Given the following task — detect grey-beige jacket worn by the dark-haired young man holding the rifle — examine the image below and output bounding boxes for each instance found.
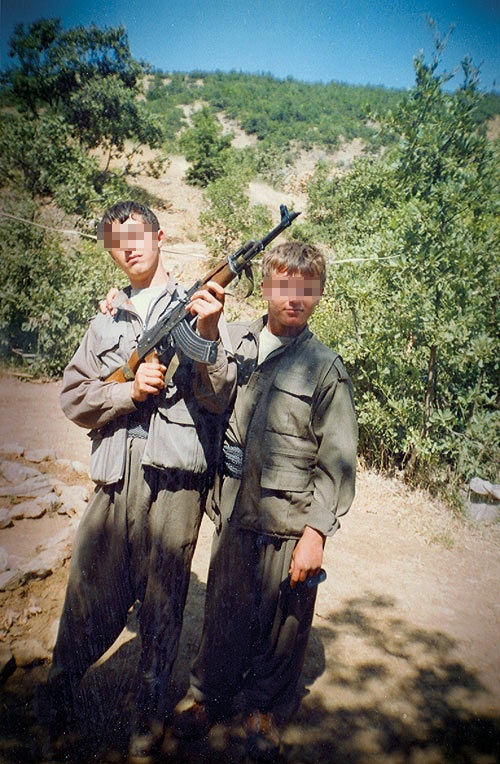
[61,280,236,484]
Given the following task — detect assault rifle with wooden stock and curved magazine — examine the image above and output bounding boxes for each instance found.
[106,204,300,382]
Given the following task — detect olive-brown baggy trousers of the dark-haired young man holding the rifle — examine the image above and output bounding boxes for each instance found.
[49,438,205,703]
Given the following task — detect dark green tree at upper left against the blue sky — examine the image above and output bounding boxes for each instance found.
[3,19,163,159]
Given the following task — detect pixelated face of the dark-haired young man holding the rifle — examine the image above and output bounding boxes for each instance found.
[101,218,164,289]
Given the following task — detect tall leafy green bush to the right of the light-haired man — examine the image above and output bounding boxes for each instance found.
[306,47,500,484]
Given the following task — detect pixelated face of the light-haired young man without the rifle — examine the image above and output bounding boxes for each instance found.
[262,271,323,337]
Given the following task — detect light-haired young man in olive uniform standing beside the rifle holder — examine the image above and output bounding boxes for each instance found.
[174,242,357,760]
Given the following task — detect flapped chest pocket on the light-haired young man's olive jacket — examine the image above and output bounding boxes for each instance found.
[268,370,315,438]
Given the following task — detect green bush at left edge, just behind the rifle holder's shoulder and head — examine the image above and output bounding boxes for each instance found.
[0,200,116,376]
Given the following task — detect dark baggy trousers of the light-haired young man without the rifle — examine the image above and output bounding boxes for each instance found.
[191,478,317,711]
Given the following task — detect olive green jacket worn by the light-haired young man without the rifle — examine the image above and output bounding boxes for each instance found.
[219,319,357,537]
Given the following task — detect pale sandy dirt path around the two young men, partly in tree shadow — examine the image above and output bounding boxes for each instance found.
[0,377,500,764]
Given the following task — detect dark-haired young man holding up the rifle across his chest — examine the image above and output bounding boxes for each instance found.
[40,202,236,757]
